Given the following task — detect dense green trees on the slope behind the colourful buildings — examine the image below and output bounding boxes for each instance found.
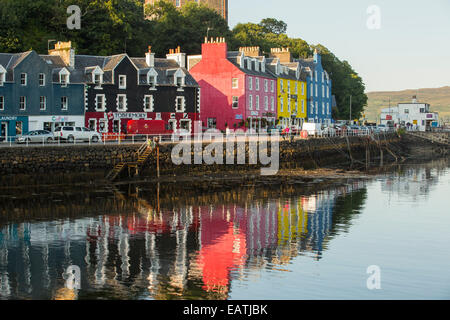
[0,0,367,119]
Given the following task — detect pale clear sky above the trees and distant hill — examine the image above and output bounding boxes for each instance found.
[229,0,450,92]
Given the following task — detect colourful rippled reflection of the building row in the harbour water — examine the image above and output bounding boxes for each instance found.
[0,179,363,299]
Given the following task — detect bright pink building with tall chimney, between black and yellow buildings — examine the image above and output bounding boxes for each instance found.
[188,38,277,130]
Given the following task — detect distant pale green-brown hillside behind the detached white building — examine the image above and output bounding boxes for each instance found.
[365,86,450,122]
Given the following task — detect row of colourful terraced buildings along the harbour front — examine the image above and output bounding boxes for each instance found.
[0,38,333,137]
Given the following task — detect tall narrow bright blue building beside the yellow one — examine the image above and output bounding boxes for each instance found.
[296,49,332,124]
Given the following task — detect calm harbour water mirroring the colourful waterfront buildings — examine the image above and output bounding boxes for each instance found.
[0,160,450,300]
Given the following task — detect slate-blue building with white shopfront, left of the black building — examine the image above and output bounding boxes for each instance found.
[0,42,85,140]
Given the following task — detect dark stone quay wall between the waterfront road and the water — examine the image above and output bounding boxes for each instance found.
[0,134,402,186]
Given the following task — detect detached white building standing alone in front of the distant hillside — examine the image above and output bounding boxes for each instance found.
[380,96,439,131]
